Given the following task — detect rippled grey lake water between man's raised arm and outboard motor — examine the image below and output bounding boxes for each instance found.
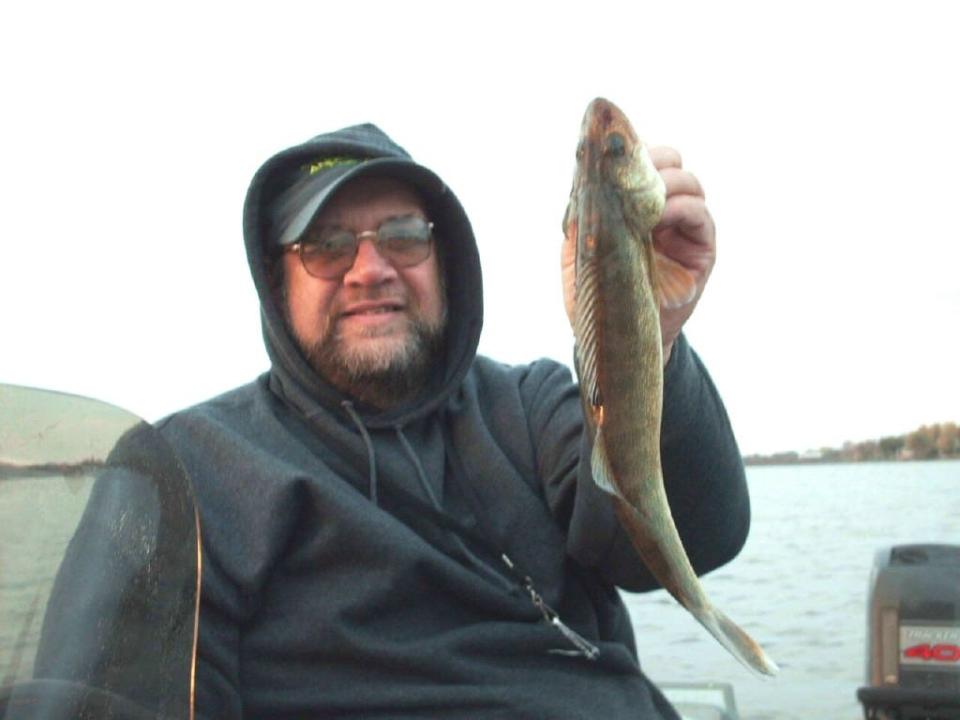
[625,461,960,720]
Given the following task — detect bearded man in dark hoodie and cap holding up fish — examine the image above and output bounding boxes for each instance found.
[160,125,749,720]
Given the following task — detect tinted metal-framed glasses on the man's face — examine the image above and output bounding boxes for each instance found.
[286,215,433,280]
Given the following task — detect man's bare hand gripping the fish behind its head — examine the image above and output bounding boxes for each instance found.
[560,147,717,364]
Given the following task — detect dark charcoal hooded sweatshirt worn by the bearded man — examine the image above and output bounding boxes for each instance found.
[160,125,749,720]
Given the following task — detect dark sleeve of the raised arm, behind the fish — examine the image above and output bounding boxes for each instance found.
[528,335,750,591]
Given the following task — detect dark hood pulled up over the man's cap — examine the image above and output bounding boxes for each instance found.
[237,124,483,428]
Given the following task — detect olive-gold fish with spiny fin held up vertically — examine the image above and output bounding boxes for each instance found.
[563,98,778,675]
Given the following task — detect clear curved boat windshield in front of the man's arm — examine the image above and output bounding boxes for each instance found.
[0,385,200,720]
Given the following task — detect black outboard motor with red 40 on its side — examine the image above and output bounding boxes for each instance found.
[857,545,960,720]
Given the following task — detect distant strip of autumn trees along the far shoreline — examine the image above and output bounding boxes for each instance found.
[743,422,960,465]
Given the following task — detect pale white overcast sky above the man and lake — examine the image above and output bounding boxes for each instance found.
[0,0,960,454]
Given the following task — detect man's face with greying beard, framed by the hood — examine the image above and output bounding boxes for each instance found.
[283,178,446,408]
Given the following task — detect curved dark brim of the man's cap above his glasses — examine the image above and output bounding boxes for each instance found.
[275,157,446,247]
